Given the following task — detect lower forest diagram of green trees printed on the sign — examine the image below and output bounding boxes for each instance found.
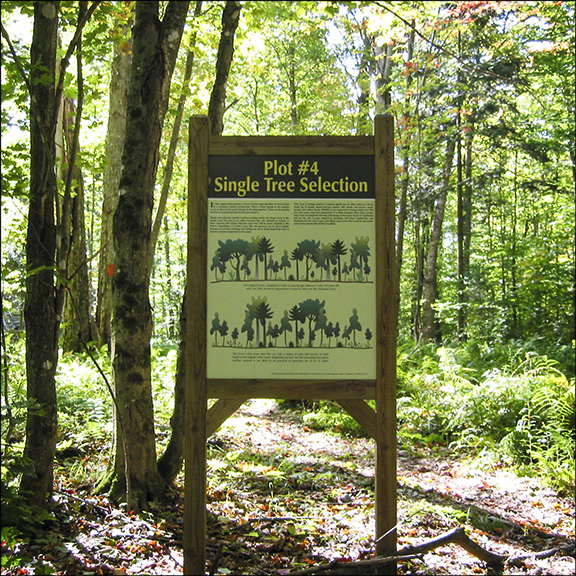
[210,296,373,349]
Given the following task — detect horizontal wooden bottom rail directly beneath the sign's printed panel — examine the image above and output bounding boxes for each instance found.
[208,378,376,400]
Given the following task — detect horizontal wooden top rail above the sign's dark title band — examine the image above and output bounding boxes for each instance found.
[210,136,374,156]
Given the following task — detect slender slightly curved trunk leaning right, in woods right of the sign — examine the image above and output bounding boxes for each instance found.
[422,134,456,341]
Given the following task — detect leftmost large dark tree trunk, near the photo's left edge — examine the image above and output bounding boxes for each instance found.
[20,1,59,506]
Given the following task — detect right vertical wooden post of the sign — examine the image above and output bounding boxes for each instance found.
[374,115,398,574]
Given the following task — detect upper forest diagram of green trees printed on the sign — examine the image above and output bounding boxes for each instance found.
[210,236,372,282]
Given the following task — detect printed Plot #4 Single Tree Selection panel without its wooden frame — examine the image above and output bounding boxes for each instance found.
[207,155,376,379]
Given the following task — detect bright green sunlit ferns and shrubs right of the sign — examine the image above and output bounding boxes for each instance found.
[398,347,575,492]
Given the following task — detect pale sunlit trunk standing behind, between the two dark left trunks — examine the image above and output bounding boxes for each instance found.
[96,19,132,346]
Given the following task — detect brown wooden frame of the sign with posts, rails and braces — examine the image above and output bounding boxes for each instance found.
[183,115,397,574]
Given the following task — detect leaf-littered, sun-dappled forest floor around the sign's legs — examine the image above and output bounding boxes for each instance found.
[2,401,575,575]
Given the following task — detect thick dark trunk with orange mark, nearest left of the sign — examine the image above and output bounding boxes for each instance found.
[105,0,189,510]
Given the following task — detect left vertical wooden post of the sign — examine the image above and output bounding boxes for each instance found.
[183,116,209,575]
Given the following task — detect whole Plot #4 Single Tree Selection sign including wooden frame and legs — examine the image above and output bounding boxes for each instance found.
[183,116,397,574]
